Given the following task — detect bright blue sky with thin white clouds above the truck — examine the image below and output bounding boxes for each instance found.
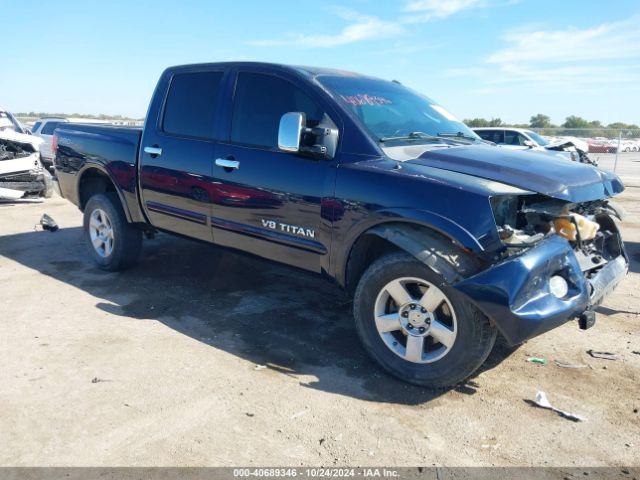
[0,0,640,124]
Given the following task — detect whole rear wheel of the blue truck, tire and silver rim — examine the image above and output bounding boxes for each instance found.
[84,193,142,271]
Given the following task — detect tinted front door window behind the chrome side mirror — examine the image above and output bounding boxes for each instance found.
[231,73,324,148]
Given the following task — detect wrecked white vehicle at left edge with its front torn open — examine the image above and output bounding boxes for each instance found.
[0,128,53,200]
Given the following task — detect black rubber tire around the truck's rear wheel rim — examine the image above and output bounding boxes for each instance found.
[83,192,142,272]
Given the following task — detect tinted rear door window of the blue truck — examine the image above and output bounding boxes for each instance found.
[162,72,222,139]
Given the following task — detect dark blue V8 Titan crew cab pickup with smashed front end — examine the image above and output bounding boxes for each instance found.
[54,63,628,387]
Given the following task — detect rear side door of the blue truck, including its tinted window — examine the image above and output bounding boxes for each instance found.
[139,69,224,241]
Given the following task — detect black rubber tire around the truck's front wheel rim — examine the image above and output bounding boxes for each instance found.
[353,252,497,388]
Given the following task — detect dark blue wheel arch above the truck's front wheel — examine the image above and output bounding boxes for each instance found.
[342,220,483,292]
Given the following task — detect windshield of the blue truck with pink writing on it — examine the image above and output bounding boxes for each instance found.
[318,75,479,141]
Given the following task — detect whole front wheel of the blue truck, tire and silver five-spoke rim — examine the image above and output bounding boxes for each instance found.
[354,253,497,388]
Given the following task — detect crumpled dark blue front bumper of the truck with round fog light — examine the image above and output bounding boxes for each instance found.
[454,235,628,345]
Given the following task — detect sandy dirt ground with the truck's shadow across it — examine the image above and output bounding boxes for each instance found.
[0,156,640,466]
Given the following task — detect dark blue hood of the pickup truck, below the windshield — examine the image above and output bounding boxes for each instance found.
[385,145,624,203]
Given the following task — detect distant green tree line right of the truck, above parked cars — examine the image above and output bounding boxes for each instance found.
[463,113,640,137]
